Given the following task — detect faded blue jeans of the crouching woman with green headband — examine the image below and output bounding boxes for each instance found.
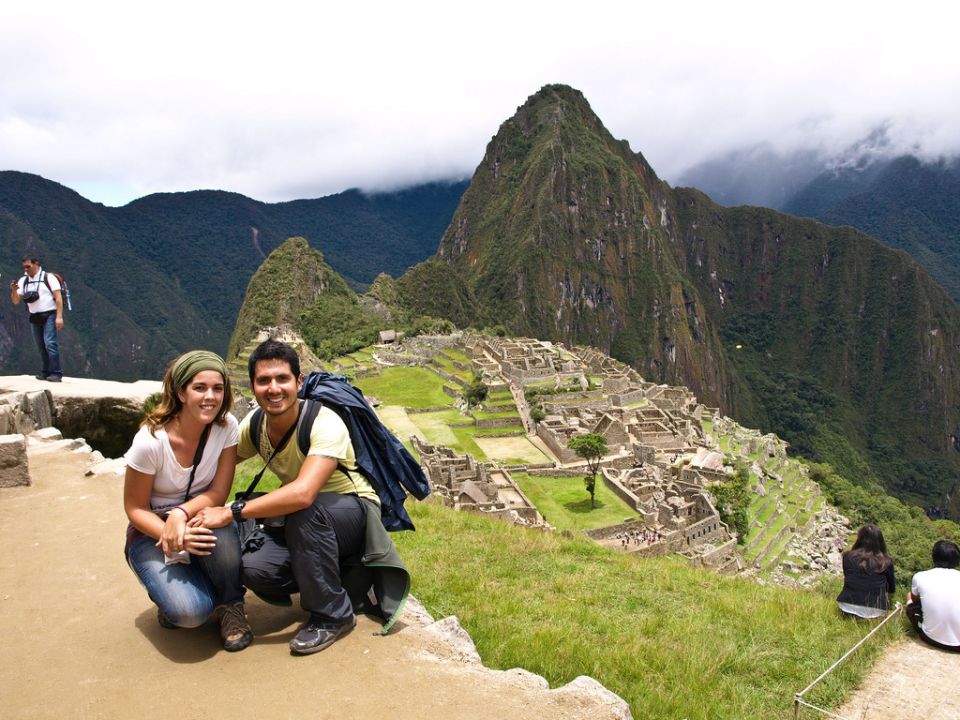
[127,523,243,627]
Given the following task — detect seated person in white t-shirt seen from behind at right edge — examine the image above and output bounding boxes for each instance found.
[906,540,960,652]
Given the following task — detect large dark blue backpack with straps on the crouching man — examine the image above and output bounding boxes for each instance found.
[250,372,430,532]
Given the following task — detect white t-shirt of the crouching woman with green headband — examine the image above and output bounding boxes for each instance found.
[124,413,240,512]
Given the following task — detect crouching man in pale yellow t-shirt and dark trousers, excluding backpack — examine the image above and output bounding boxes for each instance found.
[196,340,410,655]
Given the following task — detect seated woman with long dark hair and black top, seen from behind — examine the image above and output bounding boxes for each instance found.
[837,525,894,618]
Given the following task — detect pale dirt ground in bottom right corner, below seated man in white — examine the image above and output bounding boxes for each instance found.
[832,638,960,720]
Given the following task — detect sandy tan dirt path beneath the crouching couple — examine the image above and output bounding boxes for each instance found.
[0,451,623,720]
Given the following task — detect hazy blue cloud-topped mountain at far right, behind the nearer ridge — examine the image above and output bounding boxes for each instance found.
[784,156,960,301]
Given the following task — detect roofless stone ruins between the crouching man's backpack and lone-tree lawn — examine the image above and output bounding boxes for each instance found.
[411,436,546,527]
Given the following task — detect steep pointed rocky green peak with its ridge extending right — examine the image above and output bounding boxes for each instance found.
[397,85,960,506]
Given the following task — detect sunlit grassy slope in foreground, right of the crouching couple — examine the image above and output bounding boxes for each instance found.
[394,502,902,720]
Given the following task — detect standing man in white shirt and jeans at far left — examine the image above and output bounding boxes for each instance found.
[10,255,63,382]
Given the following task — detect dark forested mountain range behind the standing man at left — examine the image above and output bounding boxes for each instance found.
[0,172,466,380]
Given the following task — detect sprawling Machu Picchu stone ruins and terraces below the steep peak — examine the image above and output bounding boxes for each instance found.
[237,328,849,584]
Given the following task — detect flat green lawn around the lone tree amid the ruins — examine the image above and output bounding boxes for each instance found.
[513,473,637,531]
